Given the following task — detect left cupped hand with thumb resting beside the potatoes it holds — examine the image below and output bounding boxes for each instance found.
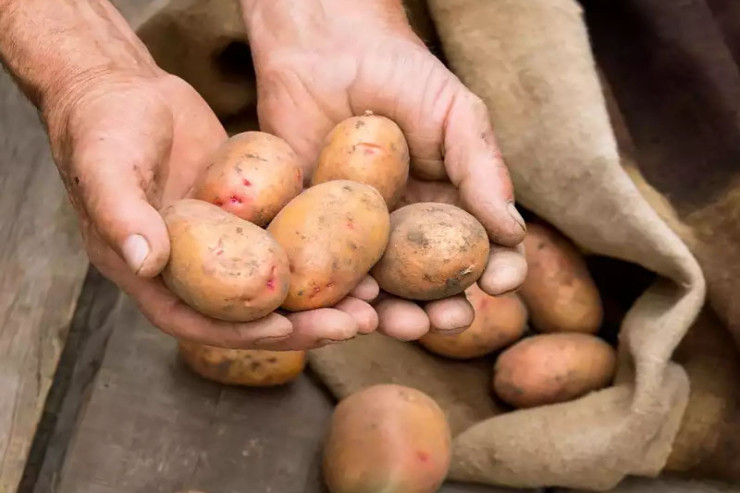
[46,74,378,350]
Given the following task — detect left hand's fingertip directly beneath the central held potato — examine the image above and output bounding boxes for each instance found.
[281,308,359,349]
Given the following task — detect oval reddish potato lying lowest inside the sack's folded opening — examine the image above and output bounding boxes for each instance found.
[493,332,616,408]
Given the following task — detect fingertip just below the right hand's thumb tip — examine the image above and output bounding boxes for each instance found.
[478,243,527,296]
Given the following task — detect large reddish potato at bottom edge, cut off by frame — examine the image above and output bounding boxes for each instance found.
[323,384,451,493]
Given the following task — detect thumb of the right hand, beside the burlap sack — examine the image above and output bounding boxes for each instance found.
[444,88,526,247]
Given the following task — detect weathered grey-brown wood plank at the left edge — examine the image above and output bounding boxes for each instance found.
[0,68,88,493]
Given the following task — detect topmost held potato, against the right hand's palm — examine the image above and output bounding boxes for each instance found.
[311,111,409,208]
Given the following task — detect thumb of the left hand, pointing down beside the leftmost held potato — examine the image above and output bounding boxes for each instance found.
[74,145,170,277]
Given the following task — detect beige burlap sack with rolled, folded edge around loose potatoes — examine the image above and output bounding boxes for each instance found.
[132,0,740,490]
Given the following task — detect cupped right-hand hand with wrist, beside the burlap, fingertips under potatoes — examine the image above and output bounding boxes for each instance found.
[242,0,526,340]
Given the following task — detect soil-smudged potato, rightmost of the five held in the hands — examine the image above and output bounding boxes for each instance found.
[372,202,490,300]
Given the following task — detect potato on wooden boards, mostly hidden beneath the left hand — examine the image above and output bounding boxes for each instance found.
[178,341,306,387]
